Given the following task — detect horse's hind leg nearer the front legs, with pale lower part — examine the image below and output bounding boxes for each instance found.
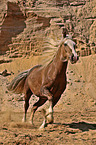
[29,98,47,124]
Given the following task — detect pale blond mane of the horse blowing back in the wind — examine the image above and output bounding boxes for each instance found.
[40,35,72,66]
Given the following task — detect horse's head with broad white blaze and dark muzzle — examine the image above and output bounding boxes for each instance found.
[63,35,79,63]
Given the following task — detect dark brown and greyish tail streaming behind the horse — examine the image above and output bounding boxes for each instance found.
[7,69,31,94]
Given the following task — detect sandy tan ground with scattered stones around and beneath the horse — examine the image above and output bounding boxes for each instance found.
[0,55,96,145]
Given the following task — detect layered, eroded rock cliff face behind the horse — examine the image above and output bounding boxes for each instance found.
[0,0,96,56]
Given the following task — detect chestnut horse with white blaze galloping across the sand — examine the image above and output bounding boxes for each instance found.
[8,32,79,128]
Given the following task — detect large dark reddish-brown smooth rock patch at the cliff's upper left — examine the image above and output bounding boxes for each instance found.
[0,2,26,54]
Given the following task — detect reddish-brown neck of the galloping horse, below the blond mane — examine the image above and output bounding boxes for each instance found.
[53,46,68,72]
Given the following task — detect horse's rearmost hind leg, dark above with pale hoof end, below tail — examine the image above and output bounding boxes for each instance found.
[22,90,32,122]
